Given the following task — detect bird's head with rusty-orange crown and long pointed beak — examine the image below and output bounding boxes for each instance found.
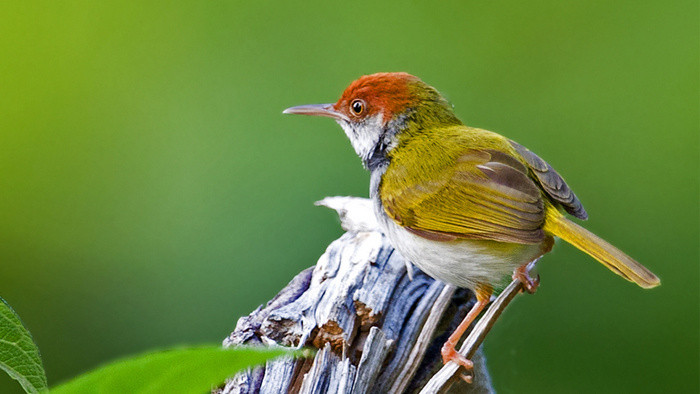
[284,73,461,169]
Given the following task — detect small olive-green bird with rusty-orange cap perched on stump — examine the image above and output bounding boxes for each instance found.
[283,72,660,380]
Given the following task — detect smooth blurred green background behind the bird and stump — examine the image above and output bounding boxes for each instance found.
[0,0,700,393]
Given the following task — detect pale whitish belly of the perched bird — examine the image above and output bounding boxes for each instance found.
[378,215,542,289]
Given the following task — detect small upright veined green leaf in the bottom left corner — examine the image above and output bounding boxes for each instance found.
[0,297,48,393]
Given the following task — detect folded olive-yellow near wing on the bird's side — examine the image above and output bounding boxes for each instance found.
[379,149,545,244]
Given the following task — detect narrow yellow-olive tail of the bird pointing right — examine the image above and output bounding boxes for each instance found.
[544,207,661,289]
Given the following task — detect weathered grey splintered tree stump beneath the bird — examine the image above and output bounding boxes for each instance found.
[215,197,500,394]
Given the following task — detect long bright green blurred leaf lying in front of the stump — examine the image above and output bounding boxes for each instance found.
[51,345,303,394]
